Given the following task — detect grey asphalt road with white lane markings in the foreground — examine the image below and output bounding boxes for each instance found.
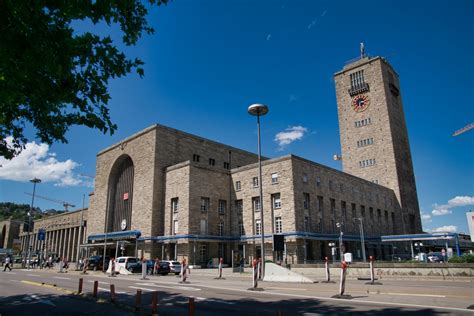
[0,269,474,316]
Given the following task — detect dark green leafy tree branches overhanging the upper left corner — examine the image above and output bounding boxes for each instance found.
[0,0,168,159]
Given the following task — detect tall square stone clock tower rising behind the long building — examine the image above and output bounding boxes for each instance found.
[334,46,422,234]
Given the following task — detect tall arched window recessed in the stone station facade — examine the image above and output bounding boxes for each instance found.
[106,155,134,232]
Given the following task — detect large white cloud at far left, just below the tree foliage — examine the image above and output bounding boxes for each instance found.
[0,137,91,186]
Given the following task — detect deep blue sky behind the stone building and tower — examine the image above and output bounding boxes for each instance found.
[0,0,474,232]
